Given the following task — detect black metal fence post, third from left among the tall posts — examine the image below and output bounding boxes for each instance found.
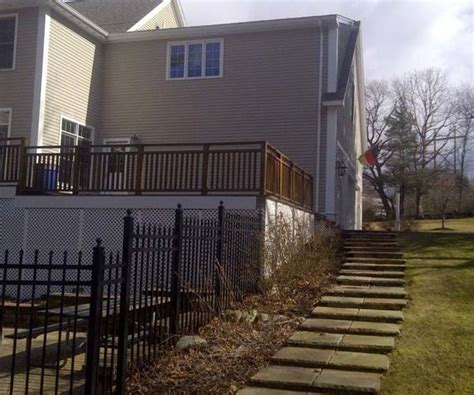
[170,204,183,335]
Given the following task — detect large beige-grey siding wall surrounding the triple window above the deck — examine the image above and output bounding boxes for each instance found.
[100,28,320,174]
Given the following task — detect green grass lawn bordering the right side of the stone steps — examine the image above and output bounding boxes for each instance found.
[382,234,474,394]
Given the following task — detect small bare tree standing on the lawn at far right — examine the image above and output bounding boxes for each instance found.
[428,170,457,229]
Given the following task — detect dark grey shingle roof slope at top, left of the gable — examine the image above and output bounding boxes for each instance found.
[64,0,163,33]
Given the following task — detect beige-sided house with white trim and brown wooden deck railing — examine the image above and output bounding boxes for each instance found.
[0,0,367,232]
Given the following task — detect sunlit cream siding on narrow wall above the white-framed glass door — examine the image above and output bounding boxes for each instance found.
[43,14,103,145]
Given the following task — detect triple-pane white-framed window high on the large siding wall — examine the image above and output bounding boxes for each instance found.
[167,39,224,80]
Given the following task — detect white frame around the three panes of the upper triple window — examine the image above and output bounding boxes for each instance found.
[166,38,224,81]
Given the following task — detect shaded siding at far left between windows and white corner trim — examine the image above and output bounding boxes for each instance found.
[0,8,38,139]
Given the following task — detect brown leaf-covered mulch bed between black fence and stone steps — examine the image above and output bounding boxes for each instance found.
[127,273,334,394]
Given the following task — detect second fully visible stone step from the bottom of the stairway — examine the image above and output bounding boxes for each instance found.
[271,347,389,373]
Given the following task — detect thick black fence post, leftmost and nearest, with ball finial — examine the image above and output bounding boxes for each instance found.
[85,239,105,395]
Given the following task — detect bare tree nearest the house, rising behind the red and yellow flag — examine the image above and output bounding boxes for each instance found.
[364,80,394,217]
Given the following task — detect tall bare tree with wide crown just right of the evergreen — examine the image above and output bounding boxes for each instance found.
[393,69,454,215]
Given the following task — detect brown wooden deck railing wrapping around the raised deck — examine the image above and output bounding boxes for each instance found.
[0,142,313,208]
